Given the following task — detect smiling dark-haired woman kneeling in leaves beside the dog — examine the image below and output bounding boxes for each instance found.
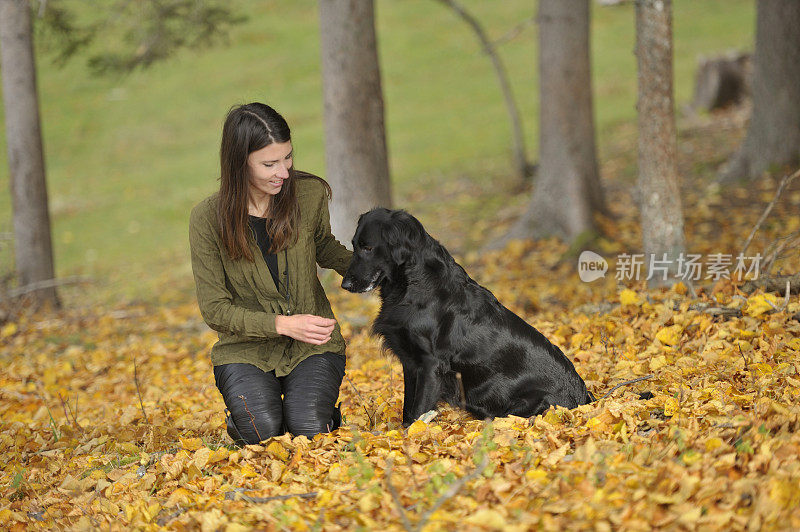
[189,103,352,444]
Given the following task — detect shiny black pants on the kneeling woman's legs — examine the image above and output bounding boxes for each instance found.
[214,352,345,444]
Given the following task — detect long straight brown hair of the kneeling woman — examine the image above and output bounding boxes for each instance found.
[217,103,331,262]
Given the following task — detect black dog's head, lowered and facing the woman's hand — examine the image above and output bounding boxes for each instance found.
[342,208,425,292]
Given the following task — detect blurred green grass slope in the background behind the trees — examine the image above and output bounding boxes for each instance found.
[0,0,755,306]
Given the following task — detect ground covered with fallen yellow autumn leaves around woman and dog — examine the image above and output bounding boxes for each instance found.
[0,110,800,530]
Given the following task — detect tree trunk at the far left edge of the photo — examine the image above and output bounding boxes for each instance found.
[0,0,58,306]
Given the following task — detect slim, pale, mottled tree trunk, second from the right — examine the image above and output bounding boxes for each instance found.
[636,0,685,287]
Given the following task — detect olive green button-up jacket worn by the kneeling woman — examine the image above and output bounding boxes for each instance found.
[189,176,352,377]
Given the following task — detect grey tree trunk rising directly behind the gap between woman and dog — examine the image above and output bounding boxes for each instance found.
[319,0,391,246]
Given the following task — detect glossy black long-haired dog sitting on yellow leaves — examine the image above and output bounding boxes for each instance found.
[342,208,594,426]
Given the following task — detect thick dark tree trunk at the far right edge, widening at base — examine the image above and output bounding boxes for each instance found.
[721,0,800,182]
